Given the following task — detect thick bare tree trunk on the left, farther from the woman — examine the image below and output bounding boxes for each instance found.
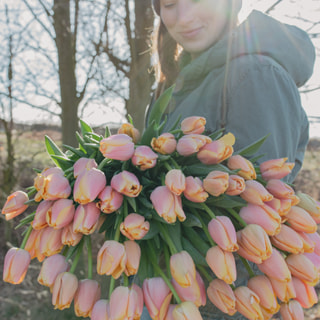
[53,0,79,146]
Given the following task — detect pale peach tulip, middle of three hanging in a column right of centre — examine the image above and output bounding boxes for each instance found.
[206,246,237,284]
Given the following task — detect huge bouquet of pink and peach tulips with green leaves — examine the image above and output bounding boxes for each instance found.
[2,88,320,320]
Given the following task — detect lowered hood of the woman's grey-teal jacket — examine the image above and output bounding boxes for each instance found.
[181,11,315,87]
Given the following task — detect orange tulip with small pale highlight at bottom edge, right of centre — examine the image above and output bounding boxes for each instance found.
[234,286,264,320]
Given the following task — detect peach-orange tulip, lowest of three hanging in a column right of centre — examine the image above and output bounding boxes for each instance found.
[207,279,237,316]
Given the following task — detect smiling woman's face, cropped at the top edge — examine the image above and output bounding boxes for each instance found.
[160,0,231,57]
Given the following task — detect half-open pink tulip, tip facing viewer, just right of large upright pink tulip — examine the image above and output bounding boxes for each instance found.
[111,170,142,198]
